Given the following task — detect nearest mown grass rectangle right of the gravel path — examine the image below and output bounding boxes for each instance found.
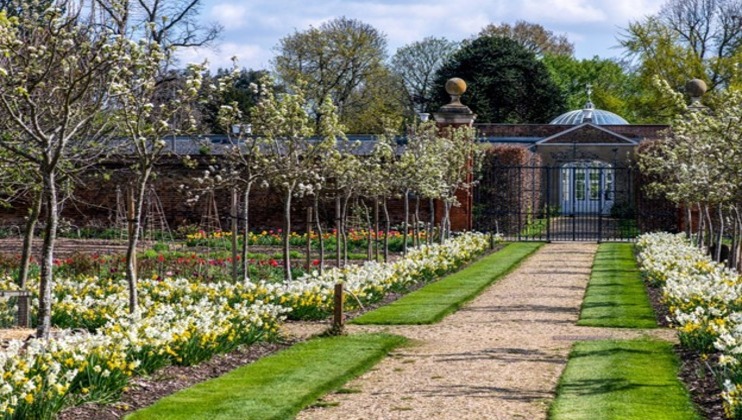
[549,340,701,420]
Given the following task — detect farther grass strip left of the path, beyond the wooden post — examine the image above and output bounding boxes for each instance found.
[352,242,543,325]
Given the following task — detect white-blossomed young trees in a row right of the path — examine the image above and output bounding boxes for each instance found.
[639,80,742,266]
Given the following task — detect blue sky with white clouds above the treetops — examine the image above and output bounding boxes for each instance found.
[180,0,665,70]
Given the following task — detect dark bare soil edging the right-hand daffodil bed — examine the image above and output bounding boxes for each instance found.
[647,280,726,420]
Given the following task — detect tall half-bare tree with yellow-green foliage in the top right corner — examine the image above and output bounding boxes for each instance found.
[620,0,742,122]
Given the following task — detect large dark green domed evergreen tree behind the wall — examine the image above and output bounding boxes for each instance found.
[434,36,565,123]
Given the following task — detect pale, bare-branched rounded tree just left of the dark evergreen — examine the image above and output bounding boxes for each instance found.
[391,36,458,113]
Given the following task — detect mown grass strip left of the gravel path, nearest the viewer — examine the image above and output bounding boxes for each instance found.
[127,334,406,420]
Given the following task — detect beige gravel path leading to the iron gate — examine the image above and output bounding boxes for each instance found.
[297,243,674,420]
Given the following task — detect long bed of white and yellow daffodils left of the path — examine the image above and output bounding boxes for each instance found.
[0,233,500,419]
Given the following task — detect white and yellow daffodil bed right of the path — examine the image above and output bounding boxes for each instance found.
[637,233,742,418]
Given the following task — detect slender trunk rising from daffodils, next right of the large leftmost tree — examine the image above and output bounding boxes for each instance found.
[126,170,150,313]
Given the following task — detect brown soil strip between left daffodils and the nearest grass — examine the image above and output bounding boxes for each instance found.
[56,342,293,420]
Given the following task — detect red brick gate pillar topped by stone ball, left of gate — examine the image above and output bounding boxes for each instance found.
[433,77,477,231]
